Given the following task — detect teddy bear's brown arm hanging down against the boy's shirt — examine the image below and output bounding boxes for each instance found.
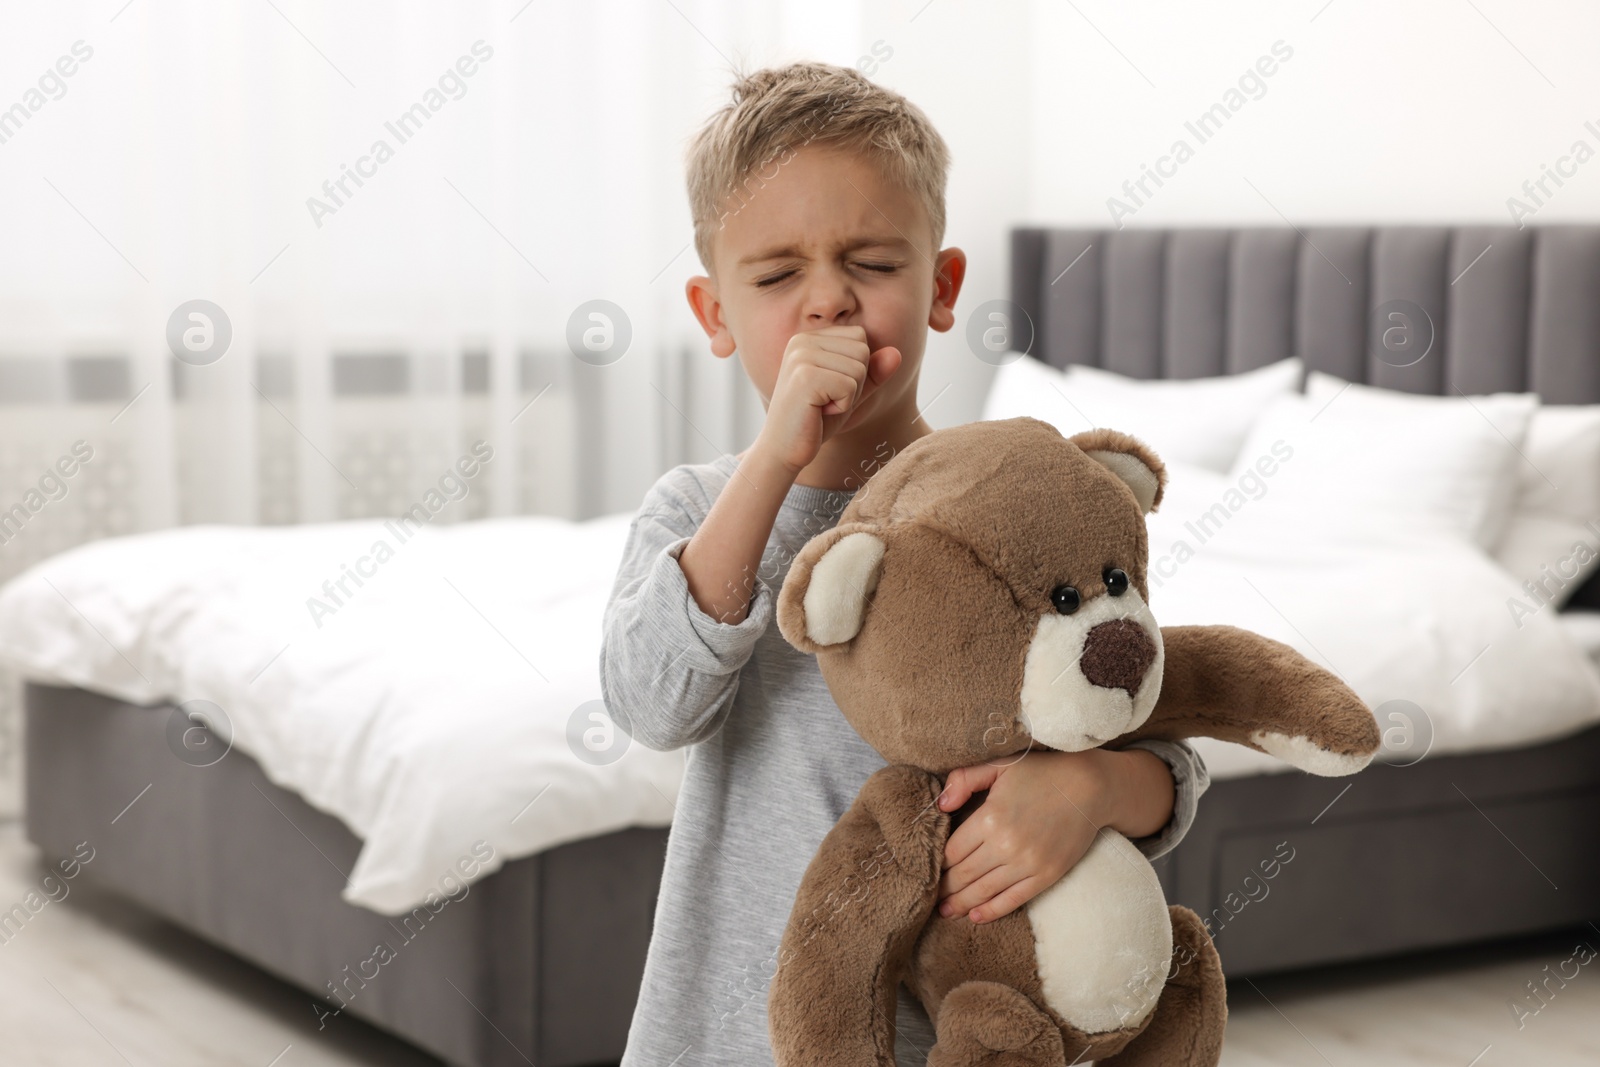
[766,766,949,1067]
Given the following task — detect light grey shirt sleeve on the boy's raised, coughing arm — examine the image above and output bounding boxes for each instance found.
[600,472,773,750]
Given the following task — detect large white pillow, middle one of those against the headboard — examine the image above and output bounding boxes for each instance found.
[1235,371,1538,553]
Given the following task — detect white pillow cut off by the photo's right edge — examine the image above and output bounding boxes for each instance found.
[1494,405,1600,606]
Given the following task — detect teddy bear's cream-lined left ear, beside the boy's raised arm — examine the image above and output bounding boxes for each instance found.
[778,523,885,653]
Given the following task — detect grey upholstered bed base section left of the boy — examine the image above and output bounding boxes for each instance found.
[24,683,667,1067]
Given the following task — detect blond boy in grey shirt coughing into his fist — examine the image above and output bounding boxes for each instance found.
[600,64,1206,1067]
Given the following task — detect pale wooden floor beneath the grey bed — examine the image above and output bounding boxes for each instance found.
[0,821,1600,1067]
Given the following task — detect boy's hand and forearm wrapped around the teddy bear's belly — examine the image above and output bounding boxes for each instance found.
[939,749,1176,923]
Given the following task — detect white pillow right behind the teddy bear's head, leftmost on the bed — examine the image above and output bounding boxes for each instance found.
[982,357,1302,474]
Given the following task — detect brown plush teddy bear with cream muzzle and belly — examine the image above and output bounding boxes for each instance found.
[768,418,1379,1067]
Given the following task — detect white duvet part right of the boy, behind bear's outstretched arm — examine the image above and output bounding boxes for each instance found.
[1149,466,1600,777]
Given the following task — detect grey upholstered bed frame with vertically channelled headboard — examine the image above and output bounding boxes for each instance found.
[26,220,1600,1067]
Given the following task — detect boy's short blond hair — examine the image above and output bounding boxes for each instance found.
[688,62,950,270]
